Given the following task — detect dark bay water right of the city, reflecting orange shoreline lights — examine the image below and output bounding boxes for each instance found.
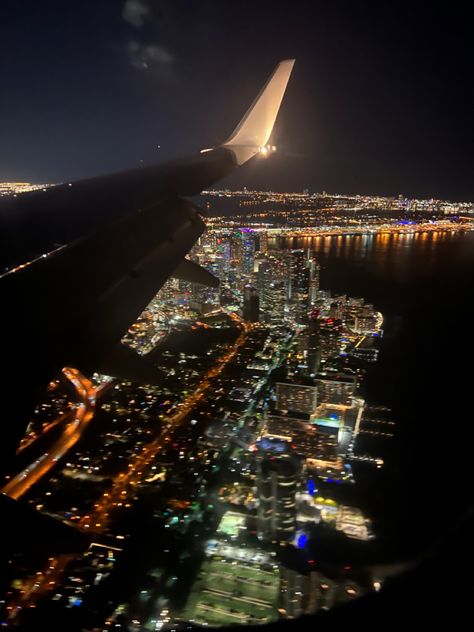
[271,232,474,548]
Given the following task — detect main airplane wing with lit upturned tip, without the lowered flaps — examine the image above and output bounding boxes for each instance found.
[0,60,294,273]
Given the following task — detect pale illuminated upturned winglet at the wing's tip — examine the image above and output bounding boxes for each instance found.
[222,59,295,165]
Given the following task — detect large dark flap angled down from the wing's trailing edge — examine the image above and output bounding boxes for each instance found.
[2,198,205,375]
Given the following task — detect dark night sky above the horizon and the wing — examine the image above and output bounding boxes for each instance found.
[0,0,474,200]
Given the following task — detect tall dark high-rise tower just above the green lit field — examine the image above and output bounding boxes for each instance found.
[257,454,299,541]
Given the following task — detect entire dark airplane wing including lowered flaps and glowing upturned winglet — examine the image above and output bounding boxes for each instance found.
[0,60,294,467]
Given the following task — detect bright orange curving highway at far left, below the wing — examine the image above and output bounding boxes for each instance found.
[1,368,98,500]
